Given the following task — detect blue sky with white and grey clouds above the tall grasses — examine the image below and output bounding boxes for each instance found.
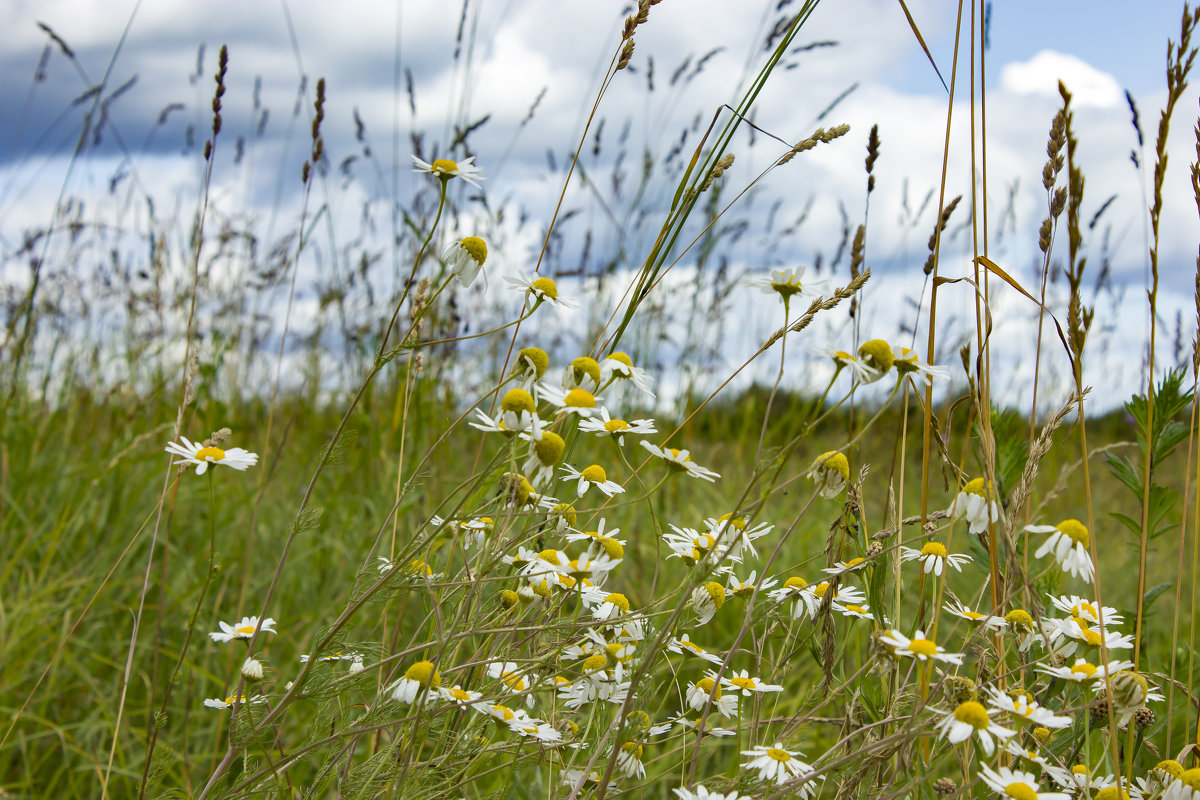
[0,0,1200,410]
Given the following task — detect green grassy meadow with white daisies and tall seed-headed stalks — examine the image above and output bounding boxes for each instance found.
[0,0,1200,800]
